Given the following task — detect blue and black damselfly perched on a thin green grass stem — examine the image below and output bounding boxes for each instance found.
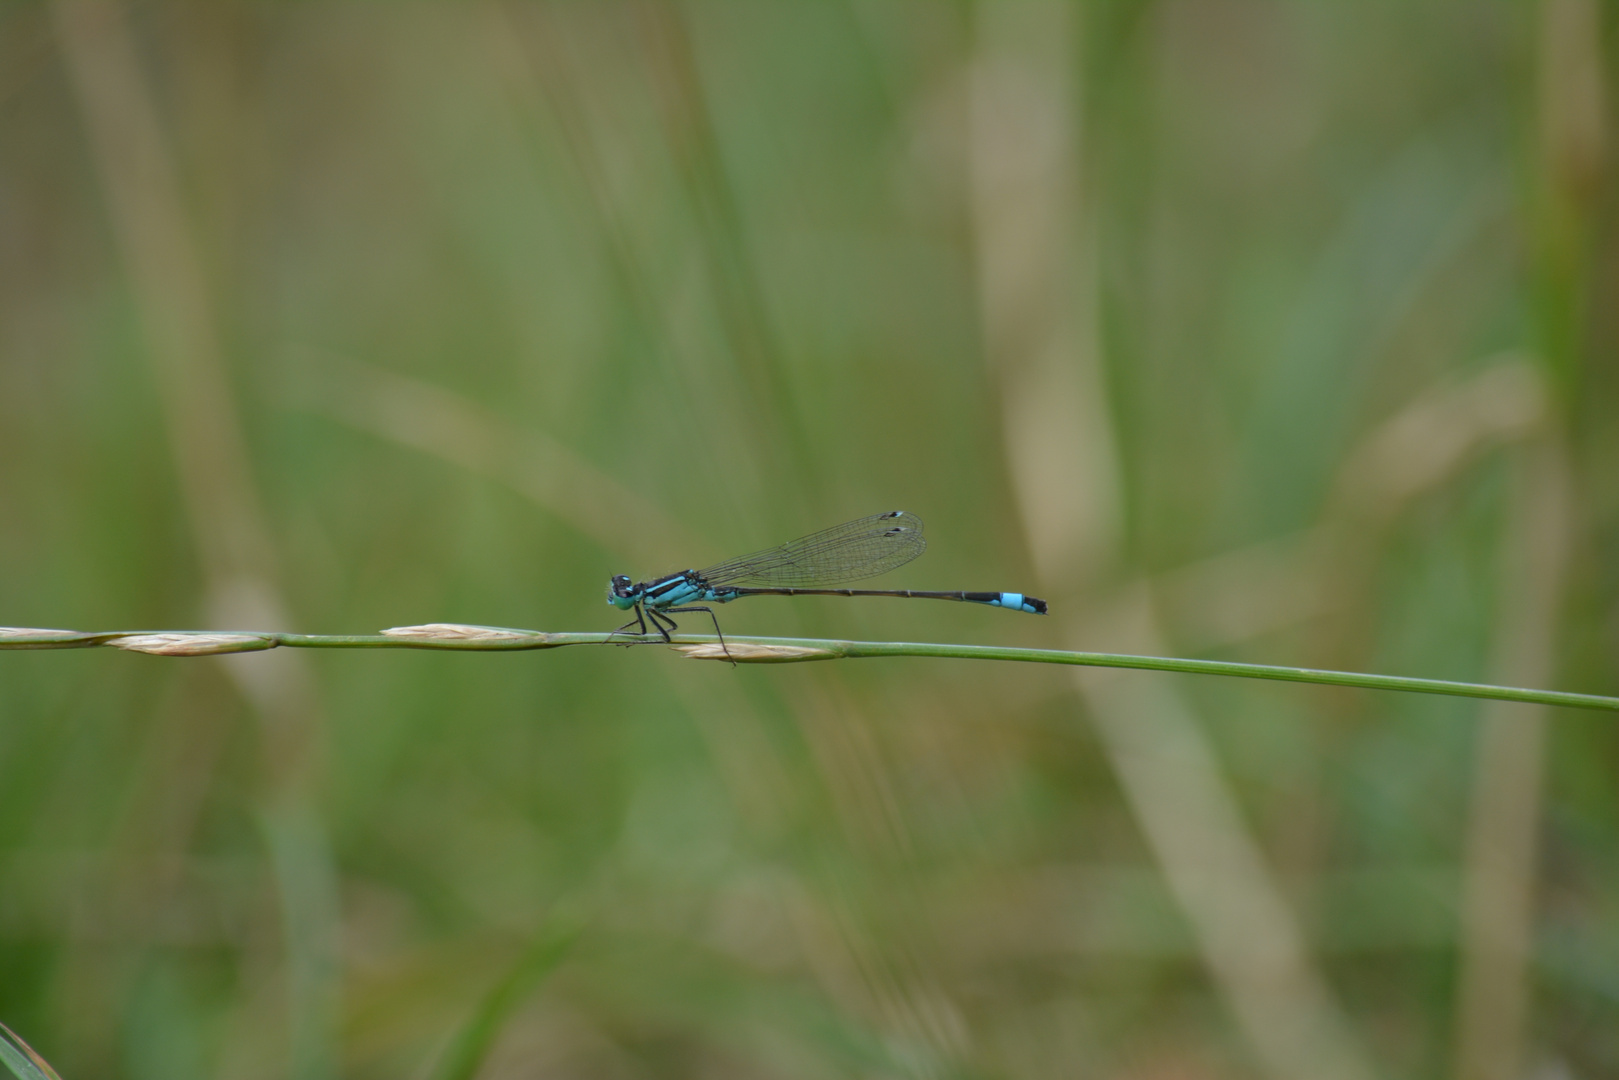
[607,510,1046,656]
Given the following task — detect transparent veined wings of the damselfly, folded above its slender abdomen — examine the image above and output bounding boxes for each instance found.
[698,510,928,588]
